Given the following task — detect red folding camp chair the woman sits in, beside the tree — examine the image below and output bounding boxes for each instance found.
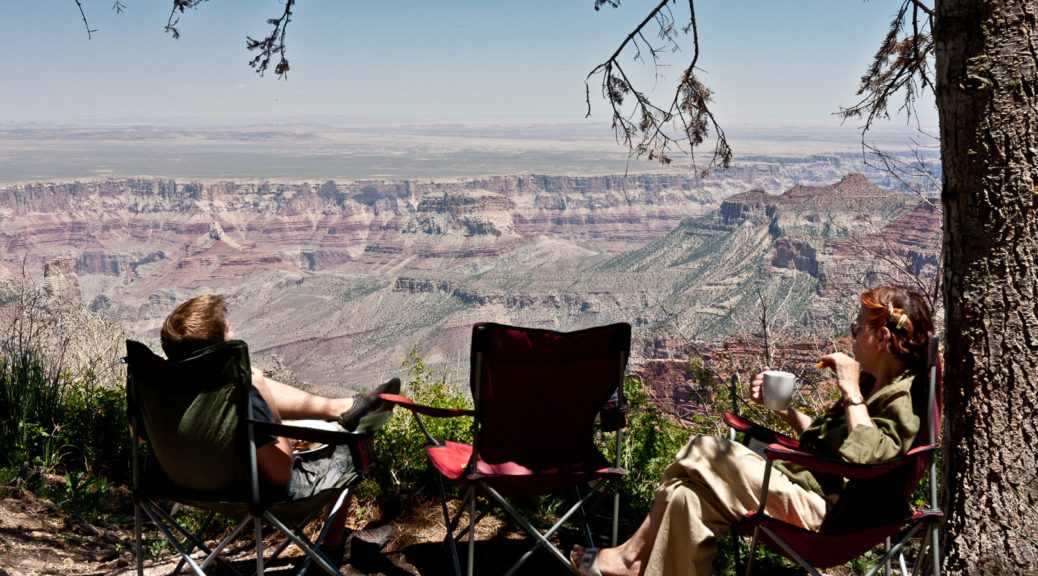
[725,336,944,576]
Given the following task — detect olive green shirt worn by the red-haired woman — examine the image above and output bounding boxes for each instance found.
[774,371,921,499]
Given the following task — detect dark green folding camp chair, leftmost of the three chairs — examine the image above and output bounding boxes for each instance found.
[125,340,377,576]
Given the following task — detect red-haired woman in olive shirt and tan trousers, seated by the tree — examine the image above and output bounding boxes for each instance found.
[571,284,933,576]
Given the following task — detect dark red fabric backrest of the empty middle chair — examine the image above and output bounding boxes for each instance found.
[470,324,631,471]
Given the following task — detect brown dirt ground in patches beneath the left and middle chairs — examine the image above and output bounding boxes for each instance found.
[0,481,571,576]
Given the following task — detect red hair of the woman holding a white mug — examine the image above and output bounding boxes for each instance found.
[862,284,933,368]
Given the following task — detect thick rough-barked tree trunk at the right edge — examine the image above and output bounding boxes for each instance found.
[933,0,1038,576]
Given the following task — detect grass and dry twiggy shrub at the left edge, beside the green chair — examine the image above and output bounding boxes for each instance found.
[0,275,129,482]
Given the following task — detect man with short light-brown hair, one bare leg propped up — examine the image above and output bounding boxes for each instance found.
[161,294,400,561]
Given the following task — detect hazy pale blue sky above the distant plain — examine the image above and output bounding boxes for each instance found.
[0,0,935,126]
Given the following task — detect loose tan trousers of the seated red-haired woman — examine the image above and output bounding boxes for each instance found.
[645,436,828,576]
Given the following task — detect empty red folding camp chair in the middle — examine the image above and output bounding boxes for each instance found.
[382,324,631,575]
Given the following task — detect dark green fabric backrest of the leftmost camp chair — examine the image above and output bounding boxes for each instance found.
[126,340,252,499]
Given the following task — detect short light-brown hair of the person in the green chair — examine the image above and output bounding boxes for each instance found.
[161,294,227,360]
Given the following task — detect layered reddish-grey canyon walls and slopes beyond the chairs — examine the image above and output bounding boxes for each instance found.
[0,161,940,392]
